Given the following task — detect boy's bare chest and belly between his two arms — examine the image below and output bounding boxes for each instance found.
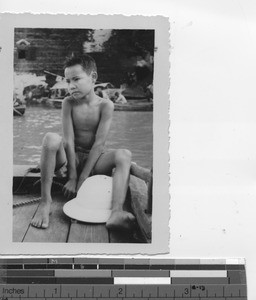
[69,97,107,150]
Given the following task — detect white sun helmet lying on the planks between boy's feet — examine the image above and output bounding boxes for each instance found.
[63,175,112,223]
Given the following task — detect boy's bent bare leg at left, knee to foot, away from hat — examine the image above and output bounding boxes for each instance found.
[31,133,66,228]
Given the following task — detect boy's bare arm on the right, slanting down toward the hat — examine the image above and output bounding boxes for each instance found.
[77,100,114,191]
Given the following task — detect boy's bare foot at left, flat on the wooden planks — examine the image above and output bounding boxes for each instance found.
[31,201,51,229]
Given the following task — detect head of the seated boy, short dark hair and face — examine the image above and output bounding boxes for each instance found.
[64,55,98,99]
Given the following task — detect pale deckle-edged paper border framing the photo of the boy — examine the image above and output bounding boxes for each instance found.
[0,14,170,255]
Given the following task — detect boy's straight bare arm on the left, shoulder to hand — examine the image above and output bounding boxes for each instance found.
[62,98,77,198]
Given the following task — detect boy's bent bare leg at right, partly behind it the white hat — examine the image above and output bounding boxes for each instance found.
[94,149,135,229]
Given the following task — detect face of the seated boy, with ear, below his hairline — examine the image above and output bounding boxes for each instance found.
[65,65,97,99]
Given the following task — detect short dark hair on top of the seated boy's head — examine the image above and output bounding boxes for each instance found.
[64,54,97,74]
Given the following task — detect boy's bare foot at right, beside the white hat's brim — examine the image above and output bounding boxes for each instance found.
[106,210,135,230]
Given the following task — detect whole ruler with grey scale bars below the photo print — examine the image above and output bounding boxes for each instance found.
[0,257,247,300]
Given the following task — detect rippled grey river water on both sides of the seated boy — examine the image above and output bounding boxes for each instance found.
[13,106,153,168]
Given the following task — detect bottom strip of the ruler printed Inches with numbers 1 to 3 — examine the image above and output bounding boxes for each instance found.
[0,284,246,300]
